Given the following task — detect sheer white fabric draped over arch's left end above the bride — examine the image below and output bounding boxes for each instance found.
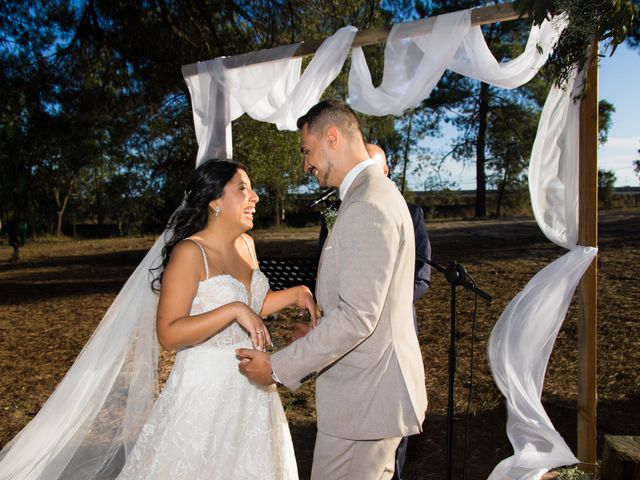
[185,26,357,165]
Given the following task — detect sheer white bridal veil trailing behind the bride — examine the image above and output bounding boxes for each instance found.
[0,237,164,480]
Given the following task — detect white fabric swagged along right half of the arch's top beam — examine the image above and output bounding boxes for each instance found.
[349,10,565,115]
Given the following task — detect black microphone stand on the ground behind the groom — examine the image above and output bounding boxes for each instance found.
[417,256,493,480]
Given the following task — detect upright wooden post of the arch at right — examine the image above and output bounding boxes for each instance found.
[577,41,598,467]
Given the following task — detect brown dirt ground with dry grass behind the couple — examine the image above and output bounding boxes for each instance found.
[0,211,640,480]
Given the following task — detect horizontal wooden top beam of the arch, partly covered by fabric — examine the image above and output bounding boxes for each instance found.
[182,3,520,77]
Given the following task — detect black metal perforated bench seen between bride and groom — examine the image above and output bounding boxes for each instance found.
[260,258,318,292]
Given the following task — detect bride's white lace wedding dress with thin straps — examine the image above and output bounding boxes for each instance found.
[118,237,298,480]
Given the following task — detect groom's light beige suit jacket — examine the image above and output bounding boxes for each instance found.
[271,166,427,440]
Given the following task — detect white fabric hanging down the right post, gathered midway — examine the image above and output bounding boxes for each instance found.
[488,66,597,480]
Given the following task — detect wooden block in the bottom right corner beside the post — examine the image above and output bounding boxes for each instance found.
[600,435,640,480]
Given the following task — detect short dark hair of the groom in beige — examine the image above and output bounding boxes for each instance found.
[297,100,363,139]
